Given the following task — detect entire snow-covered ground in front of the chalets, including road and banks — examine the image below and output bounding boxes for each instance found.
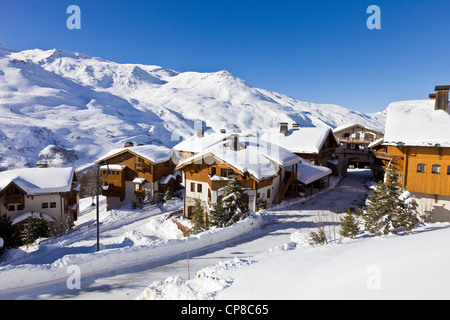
[0,170,450,300]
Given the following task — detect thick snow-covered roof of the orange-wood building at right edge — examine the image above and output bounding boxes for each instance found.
[384,100,450,148]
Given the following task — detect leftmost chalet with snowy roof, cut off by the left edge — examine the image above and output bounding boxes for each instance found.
[0,168,80,226]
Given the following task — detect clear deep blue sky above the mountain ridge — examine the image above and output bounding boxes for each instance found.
[0,0,450,113]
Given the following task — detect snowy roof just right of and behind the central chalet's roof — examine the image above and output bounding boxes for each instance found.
[261,127,337,153]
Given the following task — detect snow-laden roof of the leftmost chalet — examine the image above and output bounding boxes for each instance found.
[0,168,75,196]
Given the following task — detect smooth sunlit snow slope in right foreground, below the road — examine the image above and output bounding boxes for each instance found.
[137,223,450,300]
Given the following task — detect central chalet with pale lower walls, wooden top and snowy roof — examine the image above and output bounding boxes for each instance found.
[176,134,301,218]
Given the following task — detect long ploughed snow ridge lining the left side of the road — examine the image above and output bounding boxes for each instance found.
[0,210,264,289]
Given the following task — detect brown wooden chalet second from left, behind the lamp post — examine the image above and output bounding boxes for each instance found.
[96,144,180,210]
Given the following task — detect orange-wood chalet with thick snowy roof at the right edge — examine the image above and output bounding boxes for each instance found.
[371,86,450,222]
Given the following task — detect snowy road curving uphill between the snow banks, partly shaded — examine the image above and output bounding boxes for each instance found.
[1,170,370,300]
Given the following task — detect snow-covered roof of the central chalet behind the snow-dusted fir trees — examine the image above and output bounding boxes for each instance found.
[177,137,300,180]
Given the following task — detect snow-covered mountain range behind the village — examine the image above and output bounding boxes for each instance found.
[0,45,386,170]
